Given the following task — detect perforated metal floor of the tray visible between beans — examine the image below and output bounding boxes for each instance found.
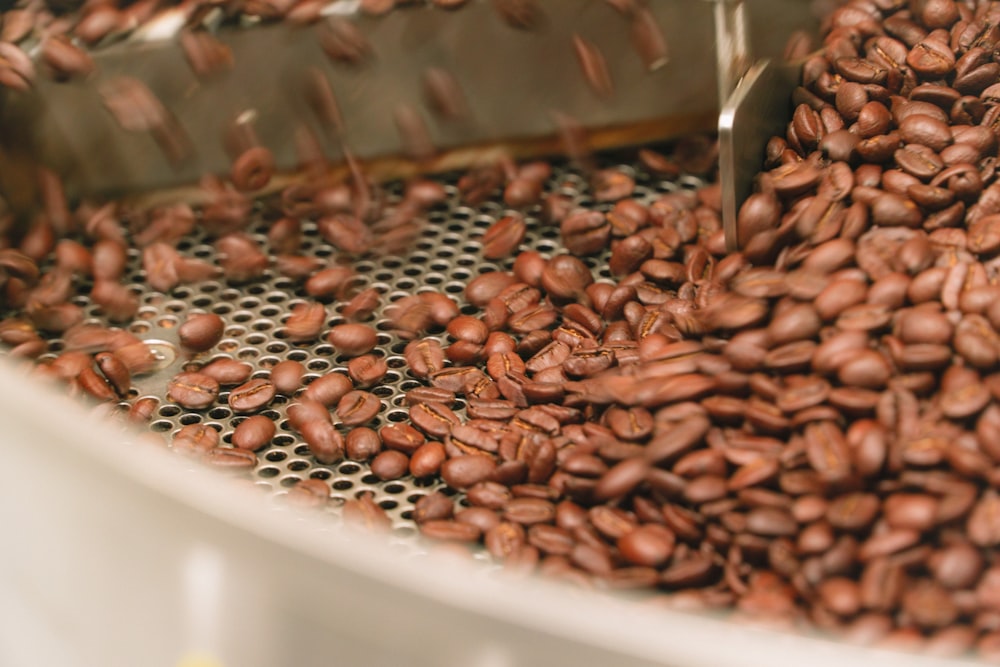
[15,157,703,552]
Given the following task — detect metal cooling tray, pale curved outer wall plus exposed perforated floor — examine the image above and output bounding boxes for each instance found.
[0,151,980,667]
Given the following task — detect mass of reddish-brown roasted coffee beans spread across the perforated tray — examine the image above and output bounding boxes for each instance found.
[13,0,1000,660]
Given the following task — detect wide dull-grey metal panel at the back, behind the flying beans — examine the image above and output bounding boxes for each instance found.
[0,0,811,224]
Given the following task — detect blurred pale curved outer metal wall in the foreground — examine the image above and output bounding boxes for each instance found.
[0,332,969,667]
